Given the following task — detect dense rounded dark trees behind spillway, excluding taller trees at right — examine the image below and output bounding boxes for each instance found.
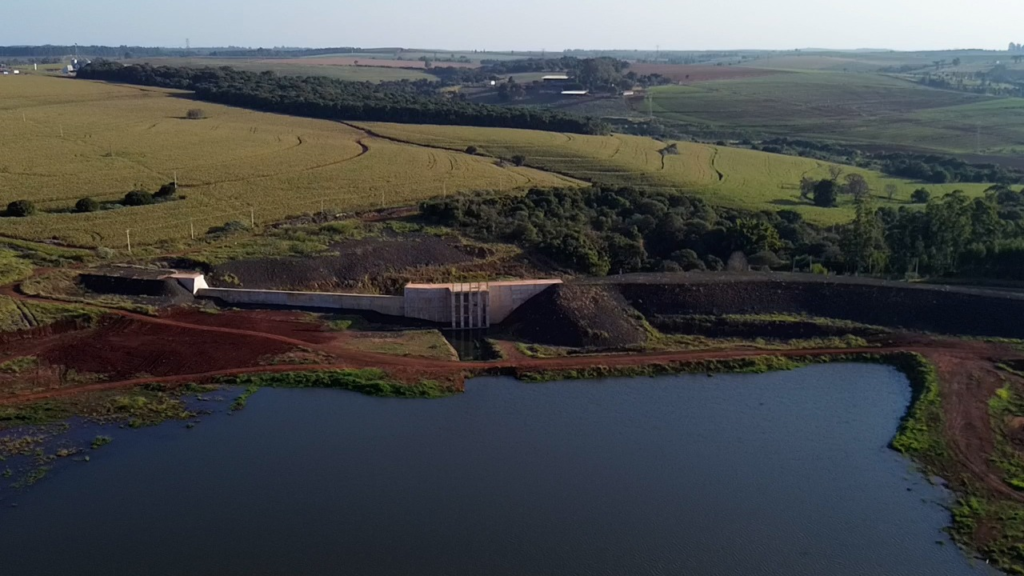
[421,183,830,276]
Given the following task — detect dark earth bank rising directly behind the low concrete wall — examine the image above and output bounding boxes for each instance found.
[211,236,476,290]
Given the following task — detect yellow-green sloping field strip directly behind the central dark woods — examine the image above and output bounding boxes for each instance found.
[360,123,988,224]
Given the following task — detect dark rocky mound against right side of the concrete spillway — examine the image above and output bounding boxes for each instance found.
[504,284,647,348]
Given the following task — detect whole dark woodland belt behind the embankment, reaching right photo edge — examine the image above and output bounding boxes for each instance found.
[421,186,1024,279]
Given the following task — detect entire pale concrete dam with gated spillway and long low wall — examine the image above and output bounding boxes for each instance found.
[169,273,562,330]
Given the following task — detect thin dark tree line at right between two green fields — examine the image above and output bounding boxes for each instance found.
[751,137,1024,183]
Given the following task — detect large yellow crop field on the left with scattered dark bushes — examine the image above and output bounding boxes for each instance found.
[0,76,573,247]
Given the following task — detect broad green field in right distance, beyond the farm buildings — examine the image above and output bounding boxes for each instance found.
[652,72,1024,154]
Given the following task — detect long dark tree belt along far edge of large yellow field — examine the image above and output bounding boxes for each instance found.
[78,60,607,134]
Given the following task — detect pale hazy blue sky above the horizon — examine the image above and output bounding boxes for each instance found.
[8,0,1024,51]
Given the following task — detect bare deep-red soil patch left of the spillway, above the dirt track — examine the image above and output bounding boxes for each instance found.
[39,318,294,379]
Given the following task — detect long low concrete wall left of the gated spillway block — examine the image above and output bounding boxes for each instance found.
[196,288,406,317]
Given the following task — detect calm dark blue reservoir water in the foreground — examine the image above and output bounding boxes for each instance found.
[0,365,993,576]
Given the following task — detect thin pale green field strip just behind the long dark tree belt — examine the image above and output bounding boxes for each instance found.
[125,57,437,82]
